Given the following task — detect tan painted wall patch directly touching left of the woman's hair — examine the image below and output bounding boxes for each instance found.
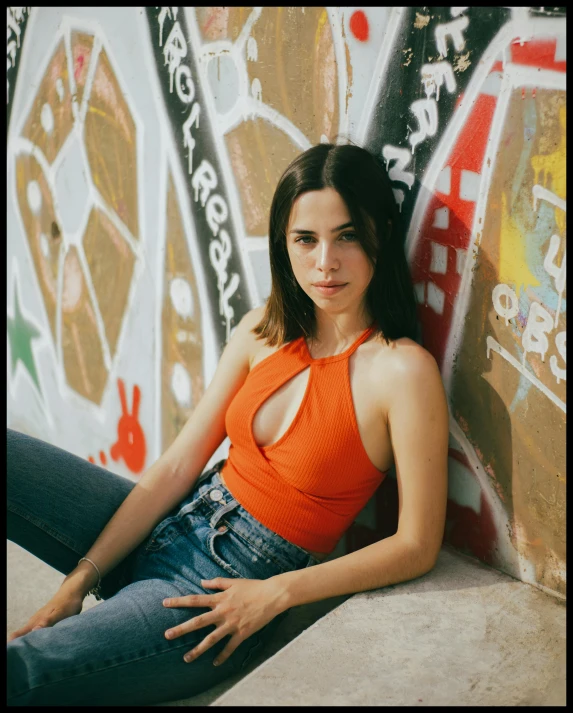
[225,118,300,235]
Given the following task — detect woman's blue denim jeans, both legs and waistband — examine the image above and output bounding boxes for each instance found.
[7,429,317,706]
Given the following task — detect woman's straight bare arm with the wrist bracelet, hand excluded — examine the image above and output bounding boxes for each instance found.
[62,308,261,596]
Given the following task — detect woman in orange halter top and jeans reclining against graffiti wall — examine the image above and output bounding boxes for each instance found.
[8,144,448,705]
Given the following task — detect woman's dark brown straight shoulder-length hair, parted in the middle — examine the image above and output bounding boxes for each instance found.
[253,144,417,346]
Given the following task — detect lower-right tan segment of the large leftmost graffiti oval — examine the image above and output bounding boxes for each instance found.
[83,208,135,359]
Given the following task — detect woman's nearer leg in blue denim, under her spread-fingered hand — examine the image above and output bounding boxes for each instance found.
[7,579,274,706]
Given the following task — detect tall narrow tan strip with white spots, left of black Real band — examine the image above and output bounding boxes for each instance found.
[161,174,204,452]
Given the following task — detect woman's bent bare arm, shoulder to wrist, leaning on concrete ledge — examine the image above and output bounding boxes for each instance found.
[272,346,449,609]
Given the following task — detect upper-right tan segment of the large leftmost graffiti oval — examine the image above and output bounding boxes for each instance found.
[85,49,139,238]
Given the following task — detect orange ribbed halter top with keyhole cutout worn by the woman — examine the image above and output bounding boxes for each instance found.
[222,326,386,552]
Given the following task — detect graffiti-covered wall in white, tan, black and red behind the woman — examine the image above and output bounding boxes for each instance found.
[7,7,567,595]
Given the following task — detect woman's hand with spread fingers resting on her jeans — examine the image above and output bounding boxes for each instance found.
[163,577,285,666]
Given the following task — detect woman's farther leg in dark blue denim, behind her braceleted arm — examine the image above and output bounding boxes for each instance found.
[6,429,137,598]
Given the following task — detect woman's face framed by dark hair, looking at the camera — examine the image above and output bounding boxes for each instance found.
[286,188,374,314]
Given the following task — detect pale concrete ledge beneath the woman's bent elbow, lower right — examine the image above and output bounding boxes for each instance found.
[209,547,566,706]
